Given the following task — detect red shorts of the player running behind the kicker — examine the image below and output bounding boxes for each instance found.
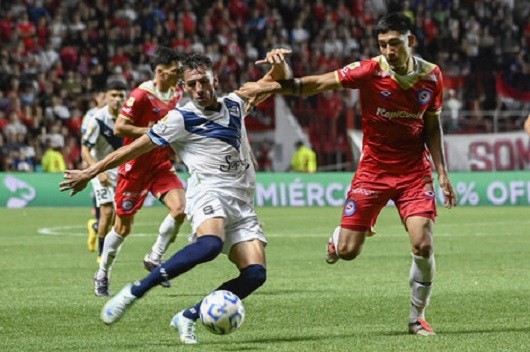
[115,169,184,216]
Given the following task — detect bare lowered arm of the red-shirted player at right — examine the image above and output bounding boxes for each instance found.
[424,112,458,208]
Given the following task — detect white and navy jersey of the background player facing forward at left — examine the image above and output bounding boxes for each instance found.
[82,105,123,173]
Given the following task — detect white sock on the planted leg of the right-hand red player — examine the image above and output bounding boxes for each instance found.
[409,254,436,323]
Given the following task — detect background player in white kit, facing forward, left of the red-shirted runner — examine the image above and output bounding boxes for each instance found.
[81,81,127,296]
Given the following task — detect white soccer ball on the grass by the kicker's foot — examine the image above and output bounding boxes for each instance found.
[199,290,245,335]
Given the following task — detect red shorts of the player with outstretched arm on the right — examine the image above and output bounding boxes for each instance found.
[341,170,436,231]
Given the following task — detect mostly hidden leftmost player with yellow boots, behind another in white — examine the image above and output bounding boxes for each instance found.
[80,90,105,254]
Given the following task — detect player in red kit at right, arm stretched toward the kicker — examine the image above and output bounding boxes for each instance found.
[242,13,457,335]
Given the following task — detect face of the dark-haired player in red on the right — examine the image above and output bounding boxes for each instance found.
[377,31,415,73]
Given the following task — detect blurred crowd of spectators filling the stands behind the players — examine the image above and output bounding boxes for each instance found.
[0,0,530,171]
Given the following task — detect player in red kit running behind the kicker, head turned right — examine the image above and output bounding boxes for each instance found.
[94,47,185,295]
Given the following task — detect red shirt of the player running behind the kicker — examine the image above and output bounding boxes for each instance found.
[119,81,182,179]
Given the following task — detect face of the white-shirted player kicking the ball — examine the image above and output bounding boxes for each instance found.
[184,67,217,108]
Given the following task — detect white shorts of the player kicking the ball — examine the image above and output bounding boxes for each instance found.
[186,192,267,254]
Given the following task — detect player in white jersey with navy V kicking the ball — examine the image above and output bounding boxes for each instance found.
[60,49,291,344]
